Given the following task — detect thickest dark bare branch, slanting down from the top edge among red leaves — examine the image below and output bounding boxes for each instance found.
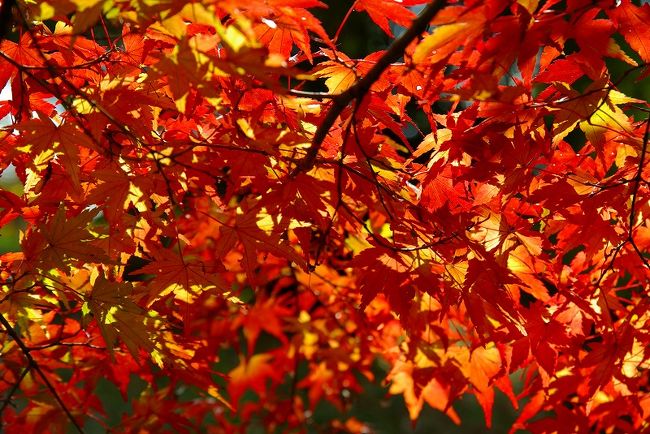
[291,0,447,176]
